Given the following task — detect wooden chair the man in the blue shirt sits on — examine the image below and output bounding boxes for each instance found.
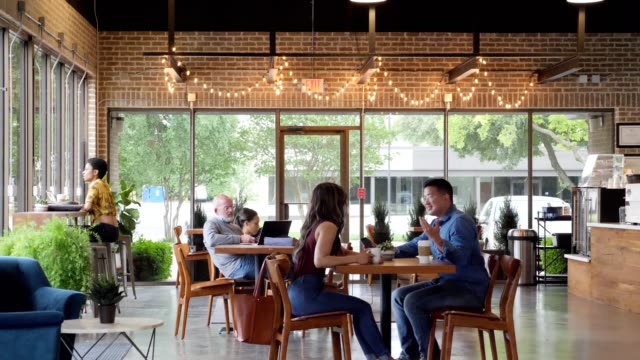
[442,255,521,360]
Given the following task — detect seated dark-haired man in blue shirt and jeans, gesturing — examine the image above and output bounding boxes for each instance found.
[391,178,489,360]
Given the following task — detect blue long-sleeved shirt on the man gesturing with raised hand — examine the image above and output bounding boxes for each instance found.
[395,205,489,301]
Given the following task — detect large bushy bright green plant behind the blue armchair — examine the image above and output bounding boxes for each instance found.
[0,218,92,292]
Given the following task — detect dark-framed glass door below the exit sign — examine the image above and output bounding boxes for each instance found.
[276,127,349,242]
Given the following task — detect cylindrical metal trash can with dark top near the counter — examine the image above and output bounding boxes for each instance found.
[507,229,538,285]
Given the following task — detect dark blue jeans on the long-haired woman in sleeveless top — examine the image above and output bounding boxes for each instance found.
[288,275,389,357]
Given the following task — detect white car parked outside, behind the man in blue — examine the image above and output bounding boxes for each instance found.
[478,195,571,249]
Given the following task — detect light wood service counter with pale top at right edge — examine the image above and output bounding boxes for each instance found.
[565,223,640,313]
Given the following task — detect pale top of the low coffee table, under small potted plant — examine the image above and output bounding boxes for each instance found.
[60,316,164,334]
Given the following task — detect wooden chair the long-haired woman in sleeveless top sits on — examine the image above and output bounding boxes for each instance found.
[267,255,351,360]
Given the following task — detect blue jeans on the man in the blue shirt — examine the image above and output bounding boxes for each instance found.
[391,278,484,359]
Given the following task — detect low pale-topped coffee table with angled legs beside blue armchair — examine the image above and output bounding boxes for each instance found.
[60,316,164,359]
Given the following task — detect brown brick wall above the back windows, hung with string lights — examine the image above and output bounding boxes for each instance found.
[97,32,640,155]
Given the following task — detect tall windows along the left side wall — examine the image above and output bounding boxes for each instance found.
[0,33,87,228]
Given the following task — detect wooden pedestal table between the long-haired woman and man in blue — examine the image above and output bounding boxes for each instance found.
[335,258,456,352]
